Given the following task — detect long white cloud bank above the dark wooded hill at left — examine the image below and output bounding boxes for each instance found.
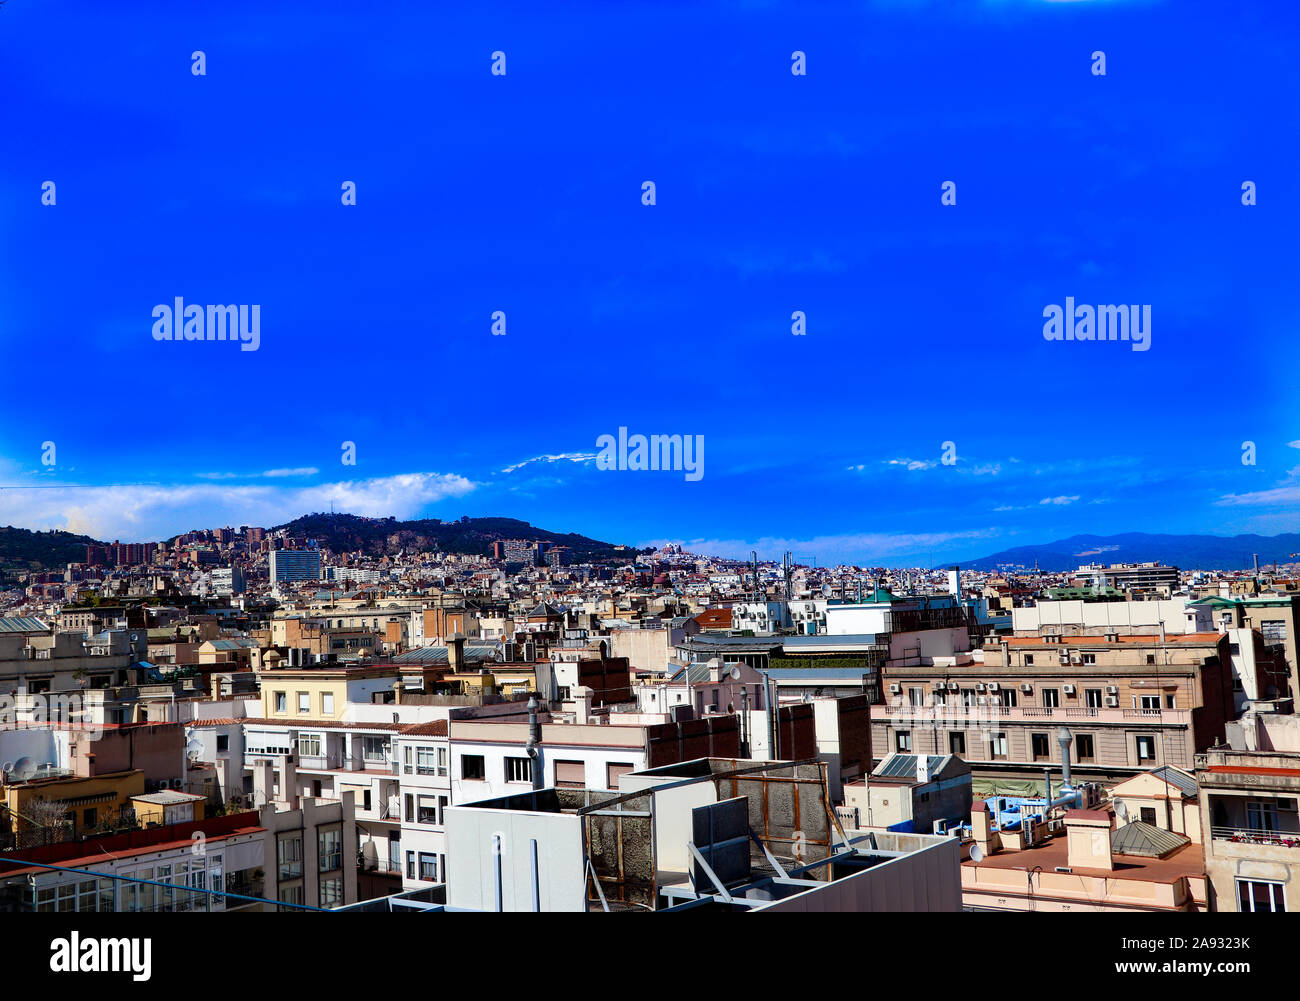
[4,473,476,542]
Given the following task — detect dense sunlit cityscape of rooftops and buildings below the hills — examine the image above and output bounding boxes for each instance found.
[0,516,1300,913]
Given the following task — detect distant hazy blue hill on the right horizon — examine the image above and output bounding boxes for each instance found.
[961,532,1300,571]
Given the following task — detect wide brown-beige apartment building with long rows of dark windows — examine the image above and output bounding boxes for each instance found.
[872,633,1235,779]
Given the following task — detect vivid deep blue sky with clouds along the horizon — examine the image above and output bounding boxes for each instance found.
[0,0,1300,563]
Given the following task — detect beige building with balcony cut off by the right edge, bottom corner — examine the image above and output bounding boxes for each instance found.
[1196,748,1300,913]
